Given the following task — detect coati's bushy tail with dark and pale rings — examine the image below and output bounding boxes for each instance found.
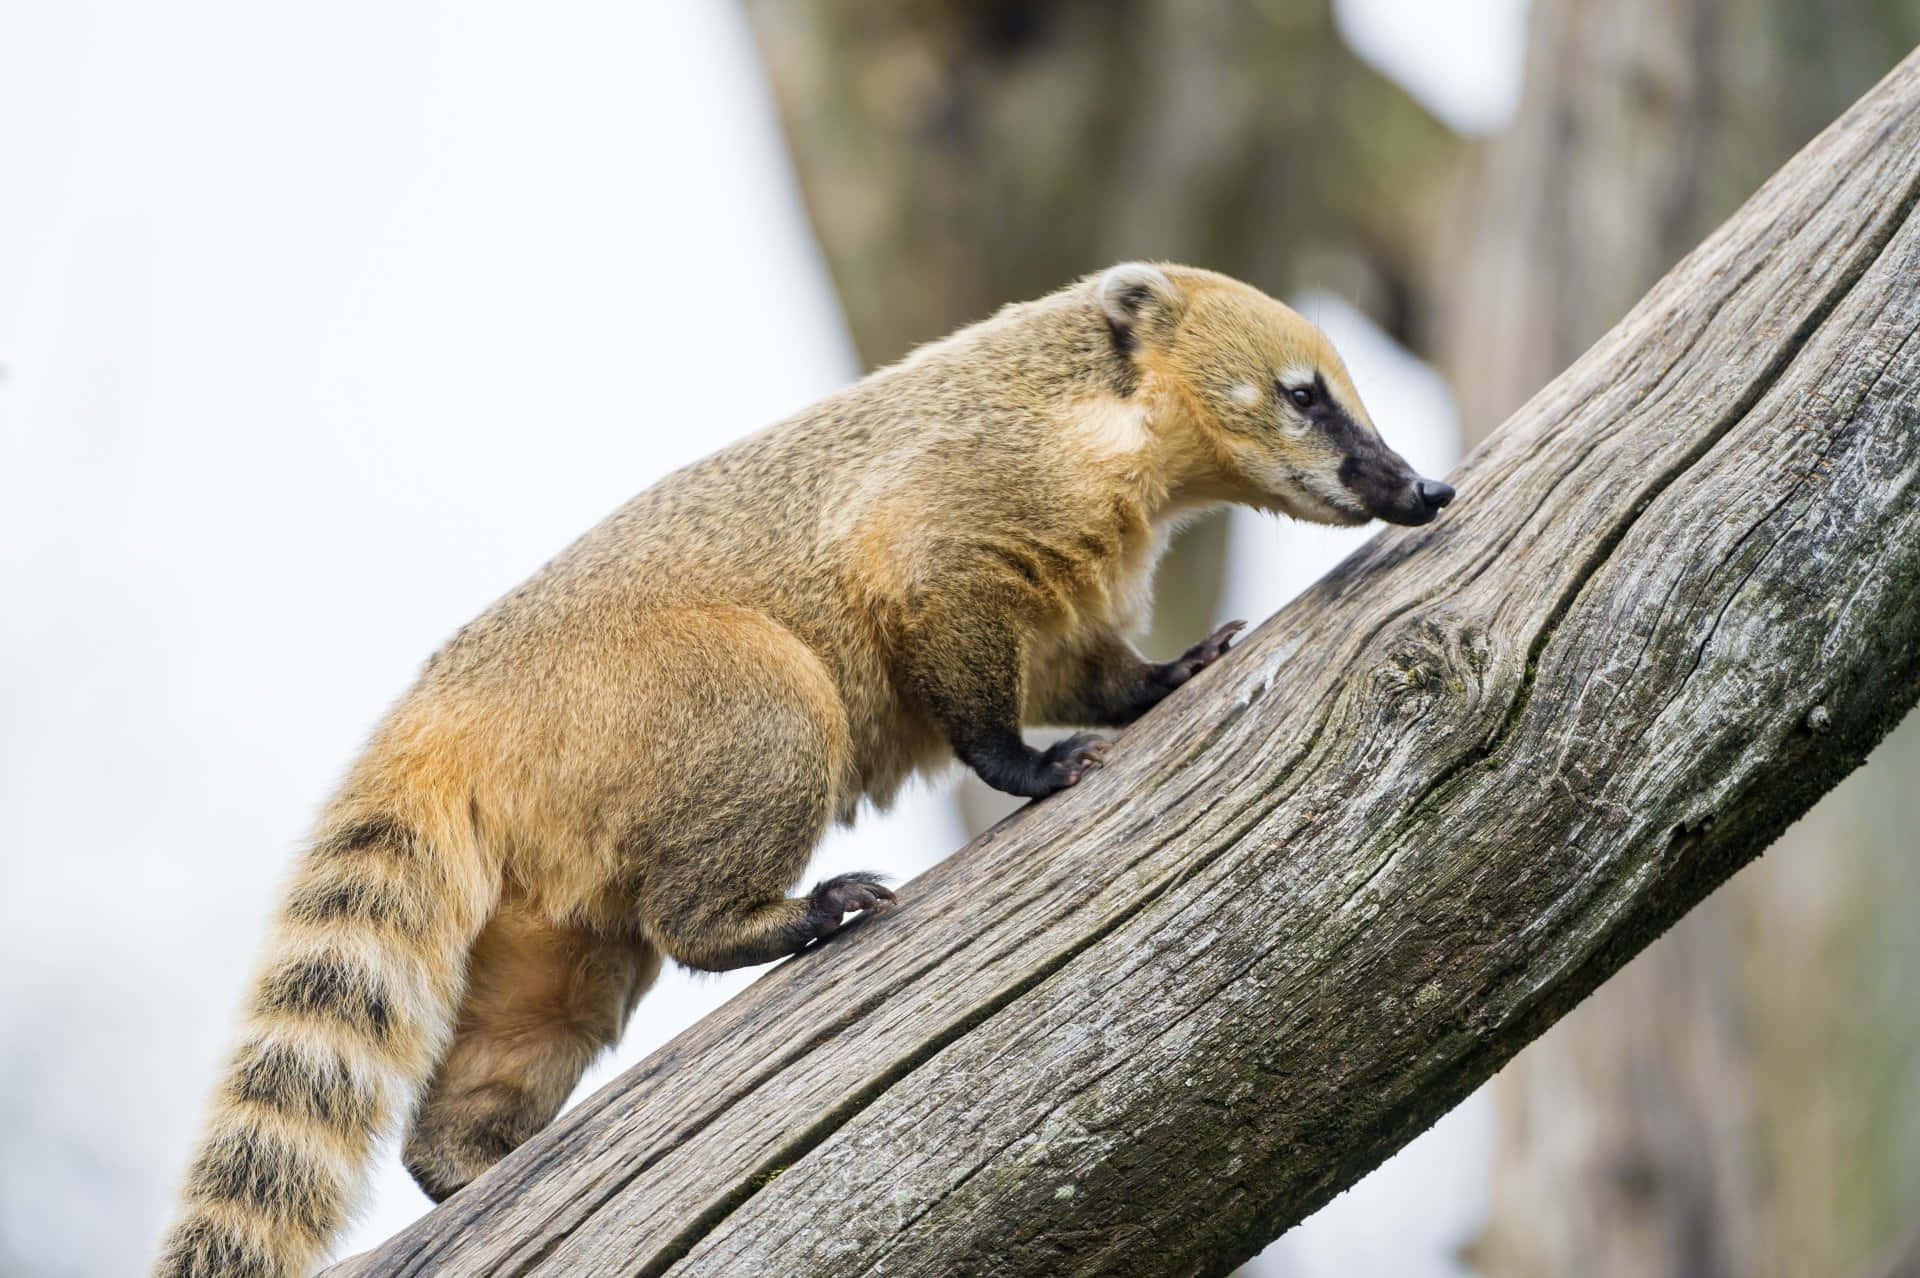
[154,804,499,1278]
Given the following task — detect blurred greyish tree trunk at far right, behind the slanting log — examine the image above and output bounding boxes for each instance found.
[1436,0,1920,1278]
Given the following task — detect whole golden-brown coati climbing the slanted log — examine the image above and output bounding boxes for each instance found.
[156,263,1453,1278]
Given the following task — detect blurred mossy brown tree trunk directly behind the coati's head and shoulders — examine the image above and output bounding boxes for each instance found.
[747,0,1465,831]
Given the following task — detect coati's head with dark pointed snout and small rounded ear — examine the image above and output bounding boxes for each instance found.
[1094,263,1453,524]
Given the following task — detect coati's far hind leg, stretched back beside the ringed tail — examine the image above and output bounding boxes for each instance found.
[401,902,660,1201]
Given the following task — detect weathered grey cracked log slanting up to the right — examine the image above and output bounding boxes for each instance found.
[336,47,1920,1276]
